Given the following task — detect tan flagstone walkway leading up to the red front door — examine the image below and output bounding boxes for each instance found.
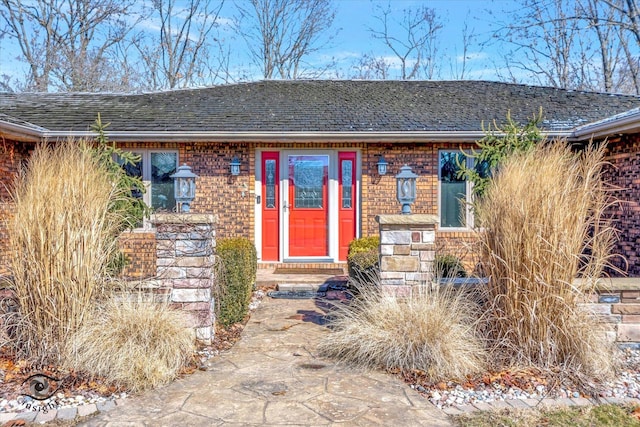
[81,298,451,427]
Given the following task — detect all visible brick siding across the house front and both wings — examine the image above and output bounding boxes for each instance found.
[5,135,640,277]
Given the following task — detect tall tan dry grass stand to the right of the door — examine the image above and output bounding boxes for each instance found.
[475,141,615,378]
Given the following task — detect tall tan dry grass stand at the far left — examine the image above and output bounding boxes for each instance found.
[7,140,124,361]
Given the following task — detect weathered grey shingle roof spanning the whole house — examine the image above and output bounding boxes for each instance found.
[0,80,640,132]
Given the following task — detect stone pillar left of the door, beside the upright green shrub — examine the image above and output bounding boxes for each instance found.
[151,213,217,343]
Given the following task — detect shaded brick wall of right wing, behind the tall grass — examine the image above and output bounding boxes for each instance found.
[605,134,640,276]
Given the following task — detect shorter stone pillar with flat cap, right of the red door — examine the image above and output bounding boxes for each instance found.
[376,214,438,295]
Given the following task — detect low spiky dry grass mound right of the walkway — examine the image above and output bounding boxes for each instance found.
[320,285,487,381]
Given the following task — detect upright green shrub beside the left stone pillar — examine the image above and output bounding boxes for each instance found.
[214,237,258,326]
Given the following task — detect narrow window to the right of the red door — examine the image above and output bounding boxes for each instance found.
[438,150,488,228]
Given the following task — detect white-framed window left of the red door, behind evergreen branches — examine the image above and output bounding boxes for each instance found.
[117,150,178,212]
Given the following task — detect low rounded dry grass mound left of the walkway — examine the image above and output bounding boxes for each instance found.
[65,296,195,392]
